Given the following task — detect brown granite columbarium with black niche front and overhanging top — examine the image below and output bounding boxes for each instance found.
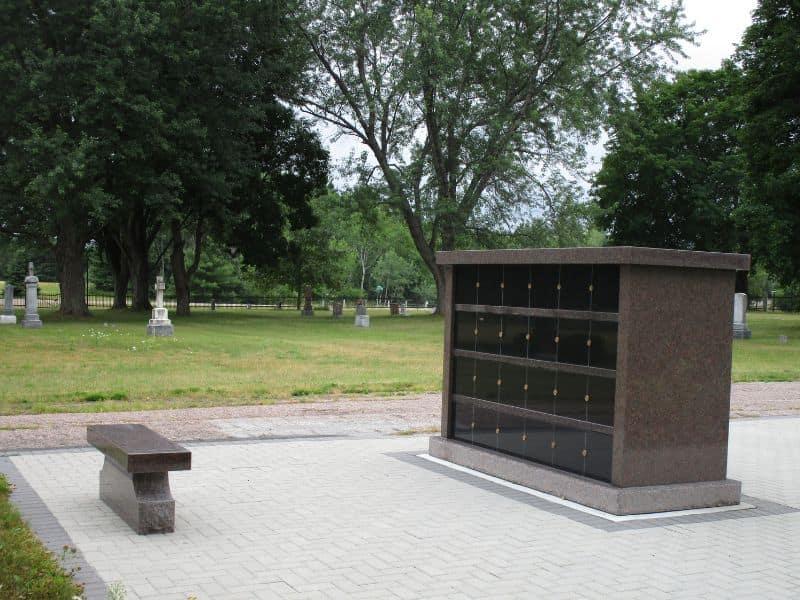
[430,247,750,515]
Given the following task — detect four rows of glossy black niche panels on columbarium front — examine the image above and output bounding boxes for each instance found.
[452,265,619,481]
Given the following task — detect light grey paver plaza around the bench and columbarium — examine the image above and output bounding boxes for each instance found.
[0,418,800,600]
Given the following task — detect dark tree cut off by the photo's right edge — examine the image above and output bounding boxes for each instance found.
[737,0,800,285]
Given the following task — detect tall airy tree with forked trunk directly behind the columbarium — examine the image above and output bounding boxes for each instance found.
[298,0,691,310]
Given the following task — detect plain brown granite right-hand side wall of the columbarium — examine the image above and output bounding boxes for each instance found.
[611,265,736,487]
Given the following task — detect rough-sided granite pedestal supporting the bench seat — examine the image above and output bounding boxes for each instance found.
[100,457,175,534]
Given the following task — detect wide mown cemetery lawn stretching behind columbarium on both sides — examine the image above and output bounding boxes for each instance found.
[0,309,800,414]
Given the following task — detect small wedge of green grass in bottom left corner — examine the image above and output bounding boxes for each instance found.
[0,475,83,600]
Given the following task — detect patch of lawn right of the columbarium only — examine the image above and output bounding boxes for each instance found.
[733,312,800,381]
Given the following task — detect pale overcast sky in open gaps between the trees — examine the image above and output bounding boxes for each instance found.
[319,0,757,180]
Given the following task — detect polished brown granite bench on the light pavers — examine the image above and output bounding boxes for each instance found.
[86,424,192,534]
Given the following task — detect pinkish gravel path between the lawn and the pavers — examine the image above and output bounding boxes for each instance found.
[0,381,800,451]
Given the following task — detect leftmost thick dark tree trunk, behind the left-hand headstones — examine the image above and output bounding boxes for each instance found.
[55,217,89,317]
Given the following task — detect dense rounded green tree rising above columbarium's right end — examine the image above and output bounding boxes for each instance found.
[594,64,744,252]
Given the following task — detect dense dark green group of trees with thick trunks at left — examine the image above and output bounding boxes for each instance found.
[0,0,327,314]
